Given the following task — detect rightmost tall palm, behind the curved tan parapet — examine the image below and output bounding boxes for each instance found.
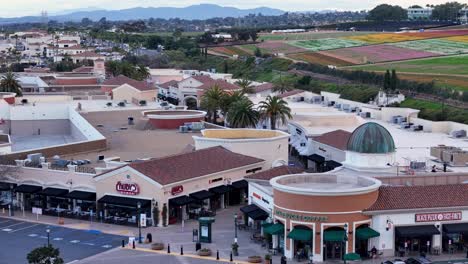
[258,95,292,130]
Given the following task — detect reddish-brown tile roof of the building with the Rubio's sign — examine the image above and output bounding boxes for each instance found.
[128,146,264,185]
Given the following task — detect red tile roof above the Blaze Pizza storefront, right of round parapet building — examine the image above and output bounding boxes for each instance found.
[366,184,468,211]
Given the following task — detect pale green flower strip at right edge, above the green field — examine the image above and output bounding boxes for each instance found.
[392,39,468,55]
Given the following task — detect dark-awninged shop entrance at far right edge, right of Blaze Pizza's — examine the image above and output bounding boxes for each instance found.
[442,223,468,254]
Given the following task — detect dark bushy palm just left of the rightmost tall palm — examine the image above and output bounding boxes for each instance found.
[227,97,260,128]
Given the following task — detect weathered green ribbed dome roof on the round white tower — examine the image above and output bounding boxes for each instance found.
[347,122,395,154]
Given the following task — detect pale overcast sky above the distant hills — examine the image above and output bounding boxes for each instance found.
[0,0,458,17]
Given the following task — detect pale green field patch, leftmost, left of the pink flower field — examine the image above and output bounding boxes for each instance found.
[290,38,367,51]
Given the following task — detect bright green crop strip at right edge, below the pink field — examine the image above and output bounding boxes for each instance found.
[352,55,468,75]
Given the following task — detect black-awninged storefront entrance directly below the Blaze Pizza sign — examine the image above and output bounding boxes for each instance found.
[395,225,440,257]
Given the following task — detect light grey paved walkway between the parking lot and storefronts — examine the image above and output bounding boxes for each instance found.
[0,207,468,264]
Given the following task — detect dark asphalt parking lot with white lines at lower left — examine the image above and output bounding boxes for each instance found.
[0,217,125,264]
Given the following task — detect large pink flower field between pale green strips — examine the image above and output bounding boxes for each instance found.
[319,45,438,64]
